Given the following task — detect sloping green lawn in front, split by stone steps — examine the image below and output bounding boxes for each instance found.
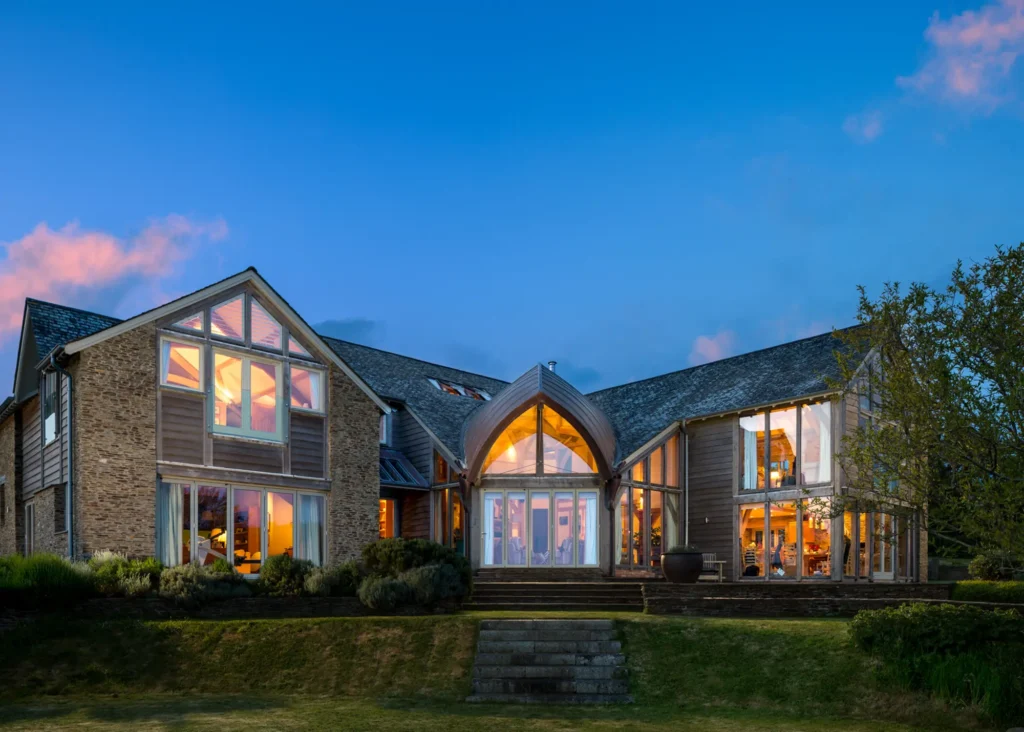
[0,613,985,732]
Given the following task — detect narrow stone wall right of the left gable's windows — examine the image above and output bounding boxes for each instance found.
[328,365,380,564]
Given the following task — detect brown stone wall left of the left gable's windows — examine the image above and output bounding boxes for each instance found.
[69,324,158,556]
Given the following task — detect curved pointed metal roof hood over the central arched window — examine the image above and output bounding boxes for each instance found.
[463,363,615,480]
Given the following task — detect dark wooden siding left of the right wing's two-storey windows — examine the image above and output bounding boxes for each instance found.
[686,418,738,578]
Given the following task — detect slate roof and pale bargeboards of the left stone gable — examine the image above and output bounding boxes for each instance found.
[15,267,391,413]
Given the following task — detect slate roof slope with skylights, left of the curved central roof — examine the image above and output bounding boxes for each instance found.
[323,336,508,460]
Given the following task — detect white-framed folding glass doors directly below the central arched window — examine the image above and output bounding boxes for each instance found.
[481,489,599,567]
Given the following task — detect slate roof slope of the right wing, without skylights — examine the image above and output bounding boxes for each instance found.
[587,327,856,457]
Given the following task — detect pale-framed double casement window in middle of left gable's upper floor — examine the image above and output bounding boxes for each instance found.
[213,350,282,440]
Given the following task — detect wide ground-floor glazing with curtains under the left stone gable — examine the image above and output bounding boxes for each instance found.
[157,481,326,574]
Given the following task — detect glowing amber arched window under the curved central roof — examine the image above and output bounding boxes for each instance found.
[483,404,597,475]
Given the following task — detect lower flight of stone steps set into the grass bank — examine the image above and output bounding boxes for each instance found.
[467,619,633,704]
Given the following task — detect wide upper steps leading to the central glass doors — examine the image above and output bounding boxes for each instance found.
[463,580,643,612]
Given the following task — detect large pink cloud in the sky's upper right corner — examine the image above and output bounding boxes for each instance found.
[896,0,1024,111]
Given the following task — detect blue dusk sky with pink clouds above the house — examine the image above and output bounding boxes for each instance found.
[0,0,1024,390]
